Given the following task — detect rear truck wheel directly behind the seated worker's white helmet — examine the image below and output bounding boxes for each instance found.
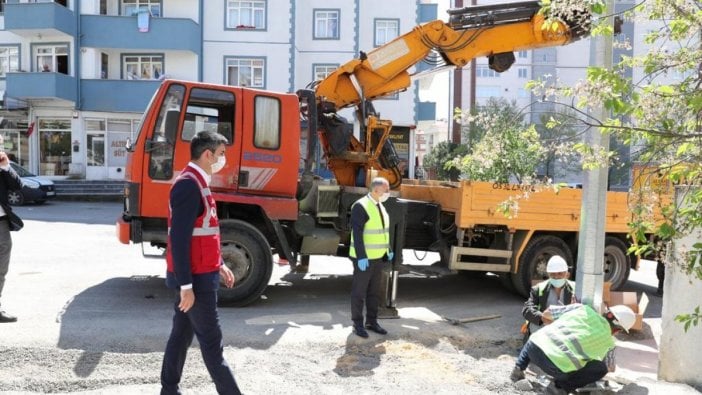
[512,236,573,298]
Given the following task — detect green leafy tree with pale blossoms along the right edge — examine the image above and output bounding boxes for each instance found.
[533,0,702,328]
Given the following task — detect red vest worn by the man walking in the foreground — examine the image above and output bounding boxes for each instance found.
[166,166,222,274]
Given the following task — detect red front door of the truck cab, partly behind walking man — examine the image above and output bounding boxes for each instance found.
[141,83,241,218]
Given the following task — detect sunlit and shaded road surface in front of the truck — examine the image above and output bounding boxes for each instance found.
[0,201,684,393]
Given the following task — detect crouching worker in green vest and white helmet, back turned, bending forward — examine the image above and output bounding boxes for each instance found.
[510,304,636,394]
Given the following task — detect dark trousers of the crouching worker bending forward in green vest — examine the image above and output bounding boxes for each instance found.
[516,341,607,392]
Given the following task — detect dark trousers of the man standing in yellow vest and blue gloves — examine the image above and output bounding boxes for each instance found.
[351,258,384,327]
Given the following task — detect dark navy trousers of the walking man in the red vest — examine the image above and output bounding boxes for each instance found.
[161,291,241,395]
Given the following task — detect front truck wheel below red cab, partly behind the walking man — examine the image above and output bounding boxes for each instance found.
[218,220,273,306]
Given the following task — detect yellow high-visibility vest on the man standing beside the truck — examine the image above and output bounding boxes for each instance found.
[349,195,390,259]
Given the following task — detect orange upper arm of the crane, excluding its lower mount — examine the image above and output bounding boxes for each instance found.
[316,1,587,110]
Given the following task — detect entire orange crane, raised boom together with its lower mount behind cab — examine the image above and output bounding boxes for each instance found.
[310,1,589,188]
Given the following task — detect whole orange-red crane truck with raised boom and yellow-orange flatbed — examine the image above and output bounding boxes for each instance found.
[117,1,632,305]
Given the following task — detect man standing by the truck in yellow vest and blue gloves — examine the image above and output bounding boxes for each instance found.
[349,177,393,338]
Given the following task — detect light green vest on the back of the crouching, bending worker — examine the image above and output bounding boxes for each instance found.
[530,305,614,373]
